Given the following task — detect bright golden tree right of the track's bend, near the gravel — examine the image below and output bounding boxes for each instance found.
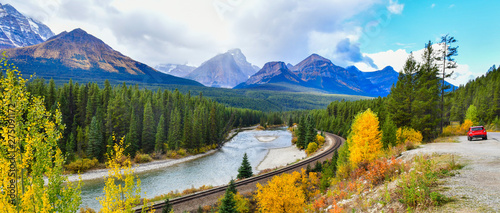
[348,109,382,168]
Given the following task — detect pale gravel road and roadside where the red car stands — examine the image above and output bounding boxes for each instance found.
[406,132,500,212]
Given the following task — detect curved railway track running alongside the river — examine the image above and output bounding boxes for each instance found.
[134,133,343,213]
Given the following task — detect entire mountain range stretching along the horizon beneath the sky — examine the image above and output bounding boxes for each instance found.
[0,4,456,97]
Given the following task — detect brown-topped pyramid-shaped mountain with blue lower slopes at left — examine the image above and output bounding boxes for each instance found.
[5,29,201,86]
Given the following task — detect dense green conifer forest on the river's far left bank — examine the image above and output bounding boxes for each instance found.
[22,79,282,160]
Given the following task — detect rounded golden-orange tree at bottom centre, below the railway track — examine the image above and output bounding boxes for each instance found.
[255,172,306,213]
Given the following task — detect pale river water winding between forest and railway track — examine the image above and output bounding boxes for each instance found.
[82,129,292,210]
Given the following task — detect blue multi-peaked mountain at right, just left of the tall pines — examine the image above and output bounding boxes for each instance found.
[234,54,398,96]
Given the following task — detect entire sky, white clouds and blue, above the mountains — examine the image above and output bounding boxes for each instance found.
[1,0,500,85]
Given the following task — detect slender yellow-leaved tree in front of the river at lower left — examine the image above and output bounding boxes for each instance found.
[97,136,148,213]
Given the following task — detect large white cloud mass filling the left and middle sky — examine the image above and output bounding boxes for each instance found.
[4,0,384,66]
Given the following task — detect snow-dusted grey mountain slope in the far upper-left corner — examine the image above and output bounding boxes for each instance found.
[0,4,54,49]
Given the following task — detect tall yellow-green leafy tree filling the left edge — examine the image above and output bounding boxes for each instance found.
[0,57,81,213]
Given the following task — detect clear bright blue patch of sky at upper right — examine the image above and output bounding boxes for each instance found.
[360,0,500,83]
